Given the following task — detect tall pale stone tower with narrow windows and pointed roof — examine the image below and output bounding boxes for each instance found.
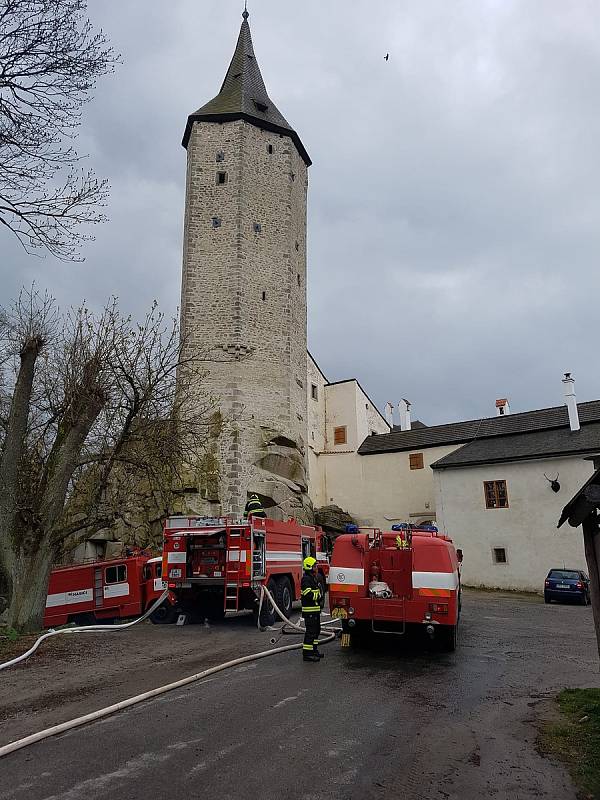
[181,11,311,520]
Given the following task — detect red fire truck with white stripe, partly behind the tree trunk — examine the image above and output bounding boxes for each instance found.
[44,554,175,628]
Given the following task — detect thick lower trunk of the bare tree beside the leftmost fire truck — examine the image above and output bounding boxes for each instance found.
[8,532,53,633]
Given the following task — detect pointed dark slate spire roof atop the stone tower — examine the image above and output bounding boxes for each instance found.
[182,8,312,166]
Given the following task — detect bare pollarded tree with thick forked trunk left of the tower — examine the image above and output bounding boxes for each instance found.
[0,291,212,630]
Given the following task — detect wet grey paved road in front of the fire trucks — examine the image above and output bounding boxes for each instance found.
[0,593,599,800]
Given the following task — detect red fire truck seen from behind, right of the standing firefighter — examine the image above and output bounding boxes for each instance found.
[329,526,460,651]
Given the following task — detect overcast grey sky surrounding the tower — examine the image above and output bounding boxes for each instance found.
[0,0,600,424]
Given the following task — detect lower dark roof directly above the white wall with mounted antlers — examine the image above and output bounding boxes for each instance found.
[431,422,600,469]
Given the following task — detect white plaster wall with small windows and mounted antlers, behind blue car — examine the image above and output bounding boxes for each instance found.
[434,456,594,592]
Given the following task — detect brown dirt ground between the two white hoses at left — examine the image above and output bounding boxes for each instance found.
[0,615,280,746]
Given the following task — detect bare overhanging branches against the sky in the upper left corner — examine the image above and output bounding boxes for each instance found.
[0,0,118,260]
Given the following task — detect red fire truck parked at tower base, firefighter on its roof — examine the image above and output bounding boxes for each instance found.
[163,517,330,621]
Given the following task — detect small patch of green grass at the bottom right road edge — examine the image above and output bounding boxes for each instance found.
[540,689,600,800]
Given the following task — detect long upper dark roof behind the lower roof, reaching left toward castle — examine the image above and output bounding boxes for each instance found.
[358,400,600,455]
